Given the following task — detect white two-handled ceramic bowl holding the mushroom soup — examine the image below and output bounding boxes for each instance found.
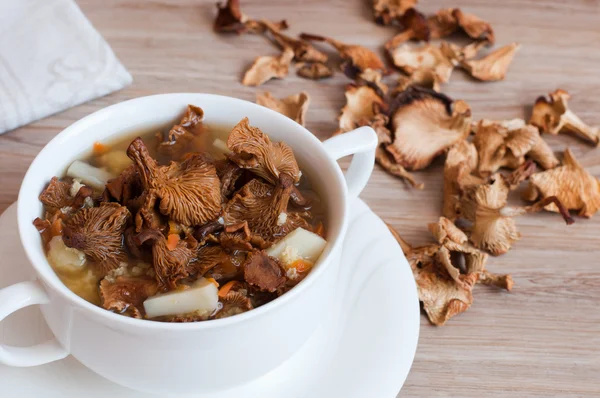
[0,94,377,393]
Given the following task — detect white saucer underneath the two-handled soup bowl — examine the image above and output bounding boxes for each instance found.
[0,200,420,398]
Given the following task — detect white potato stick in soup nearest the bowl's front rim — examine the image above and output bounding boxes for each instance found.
[144,278,219,318]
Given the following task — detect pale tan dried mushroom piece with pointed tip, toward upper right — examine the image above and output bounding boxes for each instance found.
[461,43,521,81]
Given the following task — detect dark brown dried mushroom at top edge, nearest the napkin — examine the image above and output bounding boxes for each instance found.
[213,0,287,34]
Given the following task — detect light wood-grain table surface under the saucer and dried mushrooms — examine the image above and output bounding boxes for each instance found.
[0,0,600,397]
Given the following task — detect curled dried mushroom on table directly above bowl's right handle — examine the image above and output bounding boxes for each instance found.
[338,84,385,132]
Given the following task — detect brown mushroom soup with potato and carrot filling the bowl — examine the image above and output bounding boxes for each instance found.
[33,105,326,322]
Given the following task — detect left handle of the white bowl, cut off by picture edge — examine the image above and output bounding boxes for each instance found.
[0,281,69,366]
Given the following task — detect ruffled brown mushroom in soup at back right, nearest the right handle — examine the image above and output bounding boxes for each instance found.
[227,117,300,184]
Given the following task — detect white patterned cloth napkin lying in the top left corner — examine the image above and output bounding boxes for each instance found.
[0,0,131,134]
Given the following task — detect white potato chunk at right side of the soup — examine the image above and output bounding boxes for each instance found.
[266,228,327,265]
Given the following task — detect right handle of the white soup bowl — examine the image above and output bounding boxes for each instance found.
[323,126,377,198]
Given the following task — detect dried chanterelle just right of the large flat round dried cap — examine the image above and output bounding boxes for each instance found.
[473,119,559,177]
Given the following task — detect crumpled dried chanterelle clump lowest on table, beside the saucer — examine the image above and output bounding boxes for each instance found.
[388,217,513,326]
